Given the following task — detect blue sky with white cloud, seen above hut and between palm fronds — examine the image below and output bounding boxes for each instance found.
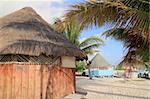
[0,0,125,65]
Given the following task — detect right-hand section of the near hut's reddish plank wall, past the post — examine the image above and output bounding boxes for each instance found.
[51,68,75,99]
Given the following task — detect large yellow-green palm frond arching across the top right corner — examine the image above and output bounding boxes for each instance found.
[64,0,149,32]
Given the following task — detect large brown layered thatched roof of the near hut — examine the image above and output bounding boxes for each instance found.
[0,7,86,59]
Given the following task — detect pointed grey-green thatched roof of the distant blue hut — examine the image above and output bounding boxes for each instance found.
[91,53,112,69]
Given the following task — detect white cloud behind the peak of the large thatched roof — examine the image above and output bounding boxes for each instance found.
[0,0,65,23]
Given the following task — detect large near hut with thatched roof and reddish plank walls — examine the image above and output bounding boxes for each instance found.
[0,7,86,99]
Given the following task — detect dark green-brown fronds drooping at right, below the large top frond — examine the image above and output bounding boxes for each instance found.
[103,28,150,63]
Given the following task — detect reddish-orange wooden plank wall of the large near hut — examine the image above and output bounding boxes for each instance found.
[0,64,75,99]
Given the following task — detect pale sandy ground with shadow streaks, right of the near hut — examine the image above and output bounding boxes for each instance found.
[66,77,150,99]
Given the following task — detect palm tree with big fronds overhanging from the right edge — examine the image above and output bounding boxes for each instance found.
[58,0,150,63]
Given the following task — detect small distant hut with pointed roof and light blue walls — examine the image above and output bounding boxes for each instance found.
[90,53,113,77]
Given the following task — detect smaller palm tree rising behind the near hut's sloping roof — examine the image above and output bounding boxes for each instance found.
[54,19,103,54]
